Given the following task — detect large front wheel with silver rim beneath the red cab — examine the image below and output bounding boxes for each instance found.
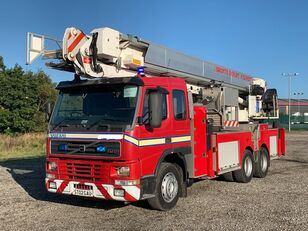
[148,163,183,211]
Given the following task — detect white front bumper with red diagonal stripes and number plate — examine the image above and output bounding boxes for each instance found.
[45,178,140,201]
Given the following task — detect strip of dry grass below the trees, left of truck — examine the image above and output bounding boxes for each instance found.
[0,133,46,161]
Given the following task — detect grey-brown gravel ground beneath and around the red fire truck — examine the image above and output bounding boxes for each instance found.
[0,132,308,231]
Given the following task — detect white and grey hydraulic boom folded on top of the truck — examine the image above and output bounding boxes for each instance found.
[28,27,279,123]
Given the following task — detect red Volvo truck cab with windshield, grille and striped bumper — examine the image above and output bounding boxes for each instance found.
[46,77,191,209]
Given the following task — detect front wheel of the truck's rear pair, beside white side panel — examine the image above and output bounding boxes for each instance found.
[233,149,253,183]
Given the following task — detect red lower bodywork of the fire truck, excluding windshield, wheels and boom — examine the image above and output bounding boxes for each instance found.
[46,77,285,209]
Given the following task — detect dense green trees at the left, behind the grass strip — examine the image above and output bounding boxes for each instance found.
[0,56,58,135]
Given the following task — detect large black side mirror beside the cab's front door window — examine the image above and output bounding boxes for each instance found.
[149,90,162,128]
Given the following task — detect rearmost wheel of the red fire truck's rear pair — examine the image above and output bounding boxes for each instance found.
[253,147,270,178]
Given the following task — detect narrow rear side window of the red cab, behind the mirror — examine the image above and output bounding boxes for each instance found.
[172,90,186,120]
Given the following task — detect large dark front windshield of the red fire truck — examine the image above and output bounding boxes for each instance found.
[50,85,138,132]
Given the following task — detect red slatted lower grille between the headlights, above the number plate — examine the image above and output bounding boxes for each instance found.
[63,161,109,182]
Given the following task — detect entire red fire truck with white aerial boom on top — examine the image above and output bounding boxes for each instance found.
[27,27,285,210]
